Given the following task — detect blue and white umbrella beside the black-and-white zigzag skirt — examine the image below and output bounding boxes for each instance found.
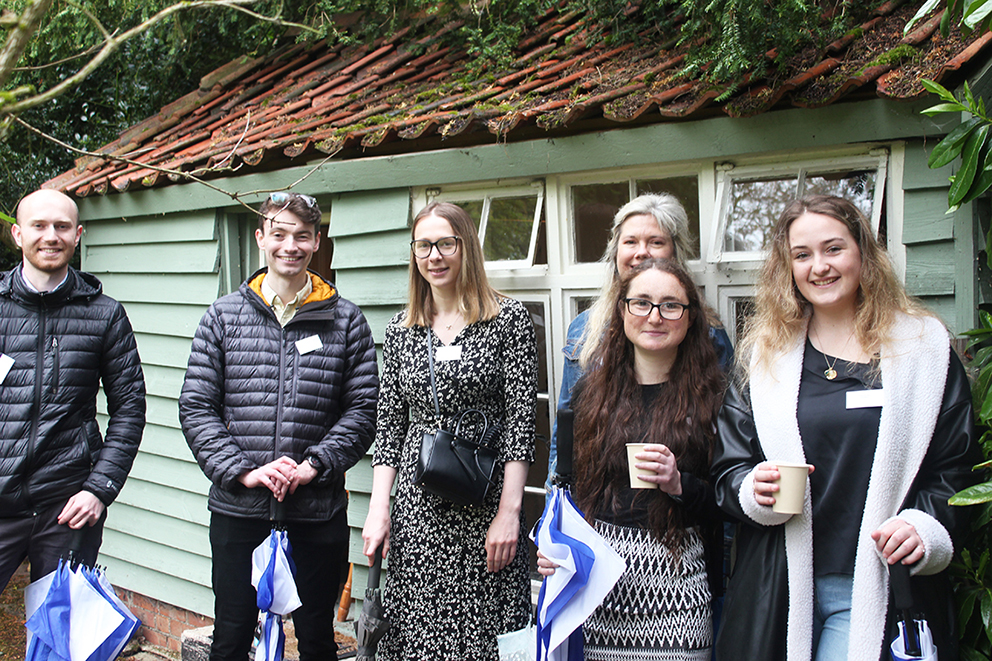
[531,409,627,661]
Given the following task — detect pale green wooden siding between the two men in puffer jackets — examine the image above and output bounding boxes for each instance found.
[81,209,218,614]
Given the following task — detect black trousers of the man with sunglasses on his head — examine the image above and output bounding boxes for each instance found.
[210,510,348,661]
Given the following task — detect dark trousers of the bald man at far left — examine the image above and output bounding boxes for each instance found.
[0,503,107,592]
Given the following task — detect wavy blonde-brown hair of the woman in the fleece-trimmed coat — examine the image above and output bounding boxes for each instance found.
[737,195,932,383]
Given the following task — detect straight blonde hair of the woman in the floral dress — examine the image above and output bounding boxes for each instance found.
[403,202,500,328]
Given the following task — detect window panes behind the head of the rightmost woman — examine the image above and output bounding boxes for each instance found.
[723,170,878,252]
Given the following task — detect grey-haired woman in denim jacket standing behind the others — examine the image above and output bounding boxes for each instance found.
[548,193,734,485]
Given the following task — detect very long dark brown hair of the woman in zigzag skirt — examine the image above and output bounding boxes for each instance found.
[574,259,724,552]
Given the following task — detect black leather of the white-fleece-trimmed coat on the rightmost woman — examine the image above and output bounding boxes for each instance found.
[712,355,981,661]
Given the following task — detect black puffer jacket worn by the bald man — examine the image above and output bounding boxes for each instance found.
[0,267,145,517]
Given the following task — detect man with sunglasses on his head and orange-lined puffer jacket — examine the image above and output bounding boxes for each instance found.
[179,193,379,661]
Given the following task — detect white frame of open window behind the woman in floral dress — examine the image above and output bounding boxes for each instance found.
[413,179,545,271]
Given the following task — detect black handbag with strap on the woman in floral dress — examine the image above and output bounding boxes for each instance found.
[413,328,499,505]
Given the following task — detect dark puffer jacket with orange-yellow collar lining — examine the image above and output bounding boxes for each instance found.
[179,269,379,521]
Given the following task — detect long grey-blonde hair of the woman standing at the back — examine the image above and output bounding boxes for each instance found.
[579,193,692,369]
